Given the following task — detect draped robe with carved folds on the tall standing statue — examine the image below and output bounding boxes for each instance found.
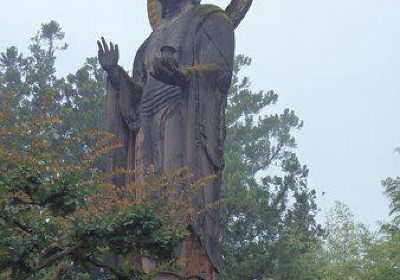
[107,5,234,279]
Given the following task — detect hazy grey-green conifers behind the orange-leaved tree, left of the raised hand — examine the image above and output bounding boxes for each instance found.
[0,21,105,161]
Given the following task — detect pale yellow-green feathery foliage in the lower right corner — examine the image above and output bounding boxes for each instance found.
[308,203,400,280]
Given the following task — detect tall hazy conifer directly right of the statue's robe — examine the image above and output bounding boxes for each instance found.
[222,56,319,280]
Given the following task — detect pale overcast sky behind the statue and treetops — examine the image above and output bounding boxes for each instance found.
[0,0,400,228]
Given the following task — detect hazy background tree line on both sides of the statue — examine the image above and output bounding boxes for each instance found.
[0,22,400,280]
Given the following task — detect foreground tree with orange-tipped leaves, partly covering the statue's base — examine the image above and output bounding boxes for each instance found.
[0,95,197,280]
